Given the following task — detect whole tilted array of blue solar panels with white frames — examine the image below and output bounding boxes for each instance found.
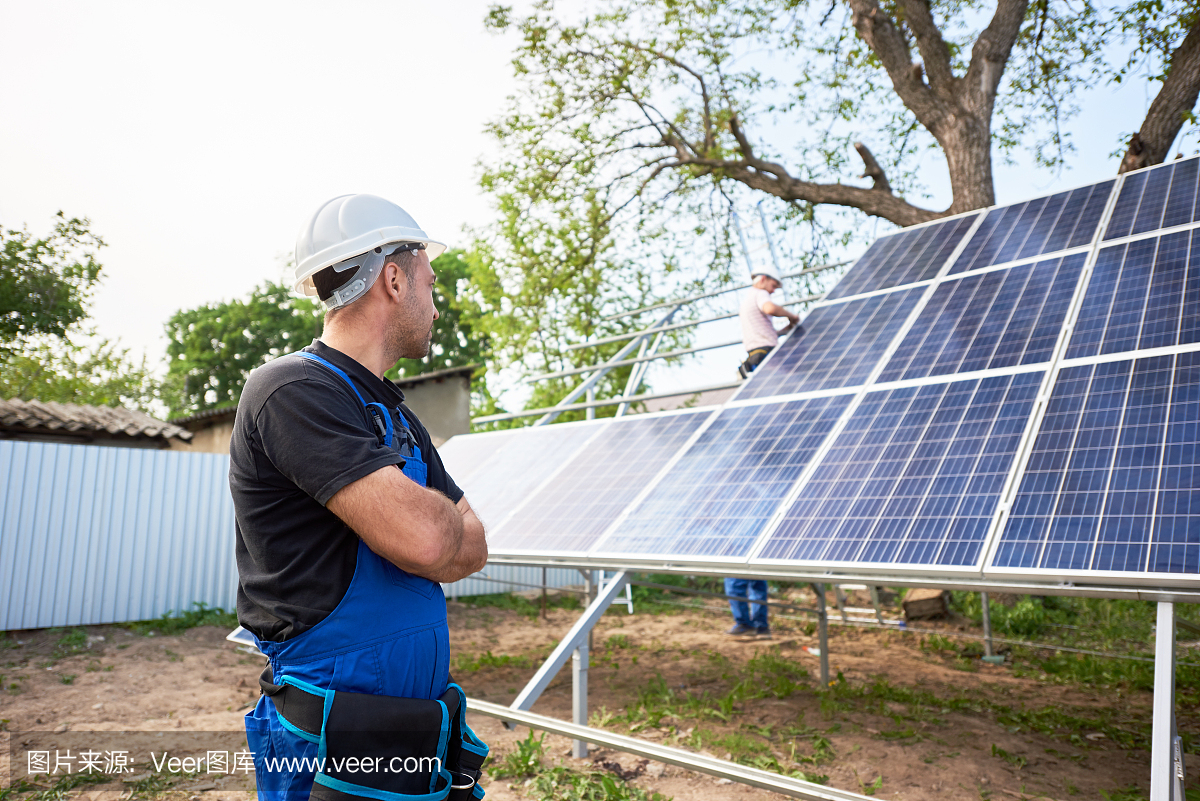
[451,158,1200,586]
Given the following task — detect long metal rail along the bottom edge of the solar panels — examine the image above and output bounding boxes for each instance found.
[487,554,1200,603]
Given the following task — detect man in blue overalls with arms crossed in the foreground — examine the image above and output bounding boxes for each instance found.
[229,194,487,801]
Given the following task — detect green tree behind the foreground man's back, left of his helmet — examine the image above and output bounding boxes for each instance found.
[163,282,323,416]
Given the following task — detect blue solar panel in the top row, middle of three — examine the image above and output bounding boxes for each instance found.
[950,181,1114,275]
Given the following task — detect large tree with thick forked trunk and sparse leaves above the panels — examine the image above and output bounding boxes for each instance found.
[485,0,1200,231]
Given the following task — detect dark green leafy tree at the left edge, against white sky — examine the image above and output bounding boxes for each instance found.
[0,211,104,359]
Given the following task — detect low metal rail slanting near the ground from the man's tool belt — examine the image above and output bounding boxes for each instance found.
[467,698,870,801]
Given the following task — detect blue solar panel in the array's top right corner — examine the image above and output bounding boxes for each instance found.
[1104,158,1200,240]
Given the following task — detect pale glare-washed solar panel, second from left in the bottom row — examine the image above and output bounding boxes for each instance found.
[488,411,713,553]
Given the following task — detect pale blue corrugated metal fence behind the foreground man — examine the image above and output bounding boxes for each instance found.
[0,440,582,631]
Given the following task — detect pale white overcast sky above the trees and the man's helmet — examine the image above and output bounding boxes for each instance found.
[0,0,1180,381]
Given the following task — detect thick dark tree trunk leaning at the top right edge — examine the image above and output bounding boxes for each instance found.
[1117,17,1200,174]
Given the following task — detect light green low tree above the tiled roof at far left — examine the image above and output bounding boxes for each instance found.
[0,331,157,414]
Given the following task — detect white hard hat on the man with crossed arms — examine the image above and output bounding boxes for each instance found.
[293,194,446,306]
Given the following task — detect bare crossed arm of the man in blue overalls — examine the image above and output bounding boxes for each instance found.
[325,466,487,583]
